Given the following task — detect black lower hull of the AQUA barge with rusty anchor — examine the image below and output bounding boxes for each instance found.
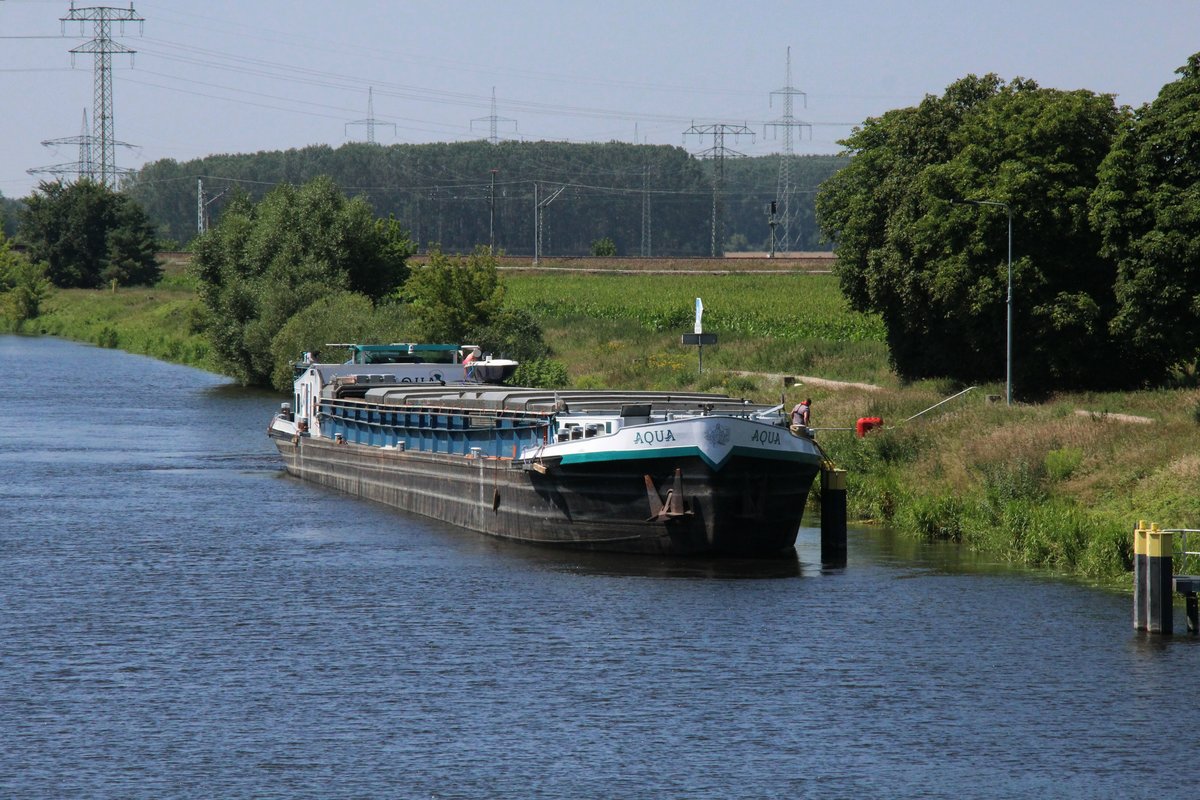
[271,433,817,555]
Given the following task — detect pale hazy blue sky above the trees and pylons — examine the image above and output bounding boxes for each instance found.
[0,0,1200,198]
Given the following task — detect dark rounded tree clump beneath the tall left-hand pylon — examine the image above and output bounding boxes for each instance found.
[18,180,162,289]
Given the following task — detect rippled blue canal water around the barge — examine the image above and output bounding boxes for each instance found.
[0,336,1200,799]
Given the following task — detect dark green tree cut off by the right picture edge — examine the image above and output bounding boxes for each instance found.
[1091,53,1200,381]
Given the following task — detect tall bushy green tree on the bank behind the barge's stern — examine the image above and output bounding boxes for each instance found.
[193,178,414,386]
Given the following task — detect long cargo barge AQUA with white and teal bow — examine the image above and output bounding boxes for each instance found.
[268,344,823,555]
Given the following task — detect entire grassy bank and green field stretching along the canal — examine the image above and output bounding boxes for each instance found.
[11,268,1200,582]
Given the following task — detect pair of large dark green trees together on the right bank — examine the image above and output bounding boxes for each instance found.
[817,54,1200,397]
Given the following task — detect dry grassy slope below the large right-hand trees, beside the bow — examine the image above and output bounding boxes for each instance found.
[822,384,1200,584]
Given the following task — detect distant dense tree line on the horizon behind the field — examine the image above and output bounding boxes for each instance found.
[126,142,846,255]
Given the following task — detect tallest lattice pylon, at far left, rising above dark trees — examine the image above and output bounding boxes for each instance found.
[59,2,145,190]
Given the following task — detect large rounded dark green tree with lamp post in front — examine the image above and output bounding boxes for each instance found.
[817,74,1124,395]
